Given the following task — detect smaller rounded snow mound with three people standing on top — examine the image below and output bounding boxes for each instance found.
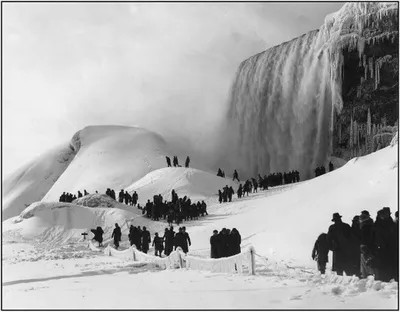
[127,167,239,204]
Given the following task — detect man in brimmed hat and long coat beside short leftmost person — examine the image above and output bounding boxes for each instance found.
[327,212,359,275]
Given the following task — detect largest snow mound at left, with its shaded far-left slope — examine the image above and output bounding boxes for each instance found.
[2,126,214,220]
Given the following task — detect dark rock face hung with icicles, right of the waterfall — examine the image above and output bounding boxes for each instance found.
[333,12,399,159]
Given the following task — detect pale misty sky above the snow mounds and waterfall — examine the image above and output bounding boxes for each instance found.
[2,2,343,178]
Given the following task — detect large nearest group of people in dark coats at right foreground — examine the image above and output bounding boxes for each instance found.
[311,207,399,282]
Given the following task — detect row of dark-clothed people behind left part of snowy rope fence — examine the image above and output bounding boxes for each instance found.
[91,223,191,257]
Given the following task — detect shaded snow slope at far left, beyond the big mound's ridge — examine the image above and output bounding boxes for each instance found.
[2,143,75,220]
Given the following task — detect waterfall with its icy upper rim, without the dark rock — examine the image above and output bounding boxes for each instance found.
[227,2,398,178]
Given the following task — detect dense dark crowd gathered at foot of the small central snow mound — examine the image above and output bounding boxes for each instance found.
[138,190,208,226]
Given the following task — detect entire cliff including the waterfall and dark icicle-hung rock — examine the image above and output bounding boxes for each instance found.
[224,2,398,178]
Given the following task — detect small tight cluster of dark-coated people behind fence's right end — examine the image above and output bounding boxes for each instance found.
[210,228,242,259]
